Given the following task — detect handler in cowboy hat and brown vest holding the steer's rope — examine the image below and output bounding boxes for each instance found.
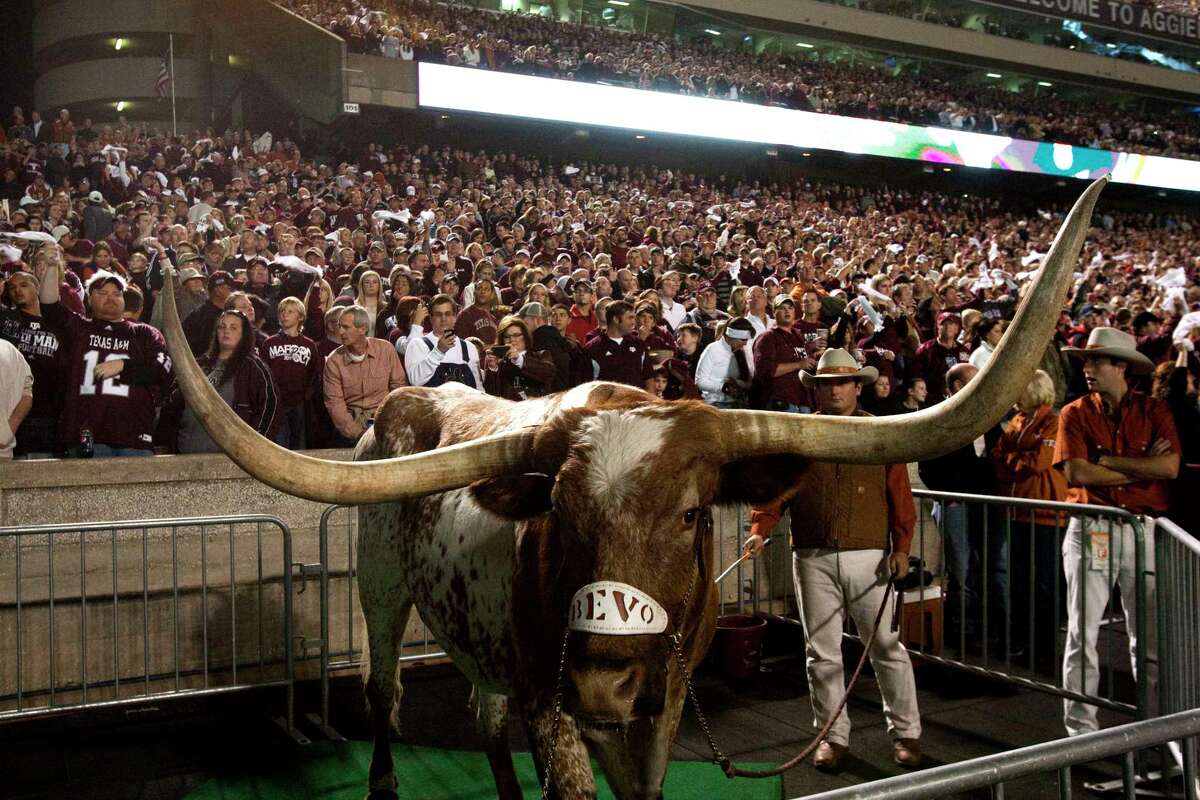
[746,348,920,771]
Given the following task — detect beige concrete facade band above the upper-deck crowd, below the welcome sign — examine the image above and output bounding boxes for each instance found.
[688,0,1200,97]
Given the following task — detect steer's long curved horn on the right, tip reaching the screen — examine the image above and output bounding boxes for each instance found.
[722,176,1109,464]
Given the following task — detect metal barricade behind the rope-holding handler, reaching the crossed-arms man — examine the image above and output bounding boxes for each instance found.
[716,491,1152,715]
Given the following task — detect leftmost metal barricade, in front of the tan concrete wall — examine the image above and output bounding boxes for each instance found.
[0,515,300,741]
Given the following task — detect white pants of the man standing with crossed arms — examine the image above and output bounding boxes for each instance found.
[1062,517,1158,736]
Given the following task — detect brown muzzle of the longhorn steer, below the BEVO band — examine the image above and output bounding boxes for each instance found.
[565,661,666,727]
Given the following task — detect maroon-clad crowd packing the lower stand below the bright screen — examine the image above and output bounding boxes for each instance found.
[0,113,1200,520]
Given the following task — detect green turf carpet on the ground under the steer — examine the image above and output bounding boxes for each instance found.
[186,741,782,800]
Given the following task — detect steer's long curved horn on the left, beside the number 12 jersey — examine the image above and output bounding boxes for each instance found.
[163,276,536,505]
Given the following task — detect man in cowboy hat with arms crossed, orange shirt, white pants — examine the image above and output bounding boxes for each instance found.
[1054,327,1182,735]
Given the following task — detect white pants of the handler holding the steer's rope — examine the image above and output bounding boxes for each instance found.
[792,549,920,745]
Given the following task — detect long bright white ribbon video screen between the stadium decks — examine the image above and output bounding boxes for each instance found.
[418,62,1200,191]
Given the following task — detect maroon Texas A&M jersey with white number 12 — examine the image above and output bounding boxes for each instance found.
[42,303,172,450]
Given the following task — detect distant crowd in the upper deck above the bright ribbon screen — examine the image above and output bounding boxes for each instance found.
[282,0,1200,158]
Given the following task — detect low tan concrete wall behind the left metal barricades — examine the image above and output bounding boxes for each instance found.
[0,451,439,714]
